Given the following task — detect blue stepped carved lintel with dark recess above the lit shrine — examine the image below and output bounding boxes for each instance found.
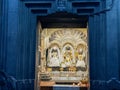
[21,0,101,27]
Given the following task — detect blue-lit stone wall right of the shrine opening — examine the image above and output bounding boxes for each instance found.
[89,0,120,90]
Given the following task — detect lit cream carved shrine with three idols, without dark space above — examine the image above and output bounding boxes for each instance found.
[36,13,90,90]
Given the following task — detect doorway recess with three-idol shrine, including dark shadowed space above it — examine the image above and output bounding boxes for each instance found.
[37,12,89,89]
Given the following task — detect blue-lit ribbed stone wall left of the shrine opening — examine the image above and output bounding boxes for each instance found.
[0,0,36,90]
